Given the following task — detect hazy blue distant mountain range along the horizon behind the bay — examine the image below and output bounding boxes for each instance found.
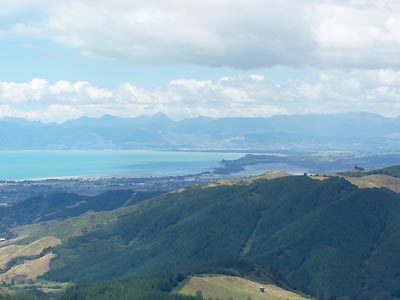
[0,113,400,151]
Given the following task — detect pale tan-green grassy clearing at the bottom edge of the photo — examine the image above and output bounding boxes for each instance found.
[177,275,307,300]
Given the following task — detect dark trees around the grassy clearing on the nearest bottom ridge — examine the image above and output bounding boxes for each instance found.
[59,259,308,300]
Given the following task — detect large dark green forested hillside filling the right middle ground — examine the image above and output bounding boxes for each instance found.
[35,176,400,299]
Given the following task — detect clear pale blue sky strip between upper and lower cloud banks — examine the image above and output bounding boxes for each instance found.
[0,38,317,88]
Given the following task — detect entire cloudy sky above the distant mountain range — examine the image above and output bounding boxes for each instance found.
[0,0,400,123]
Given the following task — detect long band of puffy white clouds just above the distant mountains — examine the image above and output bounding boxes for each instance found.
[0,69,400,122]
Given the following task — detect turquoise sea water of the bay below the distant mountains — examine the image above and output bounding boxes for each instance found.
[0,151,243,180]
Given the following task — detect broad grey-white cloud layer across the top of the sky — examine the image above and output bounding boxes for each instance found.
[0,0,400,69]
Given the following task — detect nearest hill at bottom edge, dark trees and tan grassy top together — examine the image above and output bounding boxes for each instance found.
[60,259,306,300]
